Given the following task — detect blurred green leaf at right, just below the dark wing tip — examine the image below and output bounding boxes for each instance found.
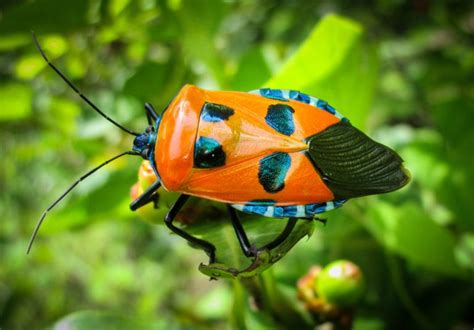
[365,200,466,277]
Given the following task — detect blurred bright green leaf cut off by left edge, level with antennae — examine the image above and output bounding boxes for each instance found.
[0,82,32,121]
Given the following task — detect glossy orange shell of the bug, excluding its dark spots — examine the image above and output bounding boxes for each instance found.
[155,85,340,205]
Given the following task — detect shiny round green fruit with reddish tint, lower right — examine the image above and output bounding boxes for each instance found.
[314,260,364,307]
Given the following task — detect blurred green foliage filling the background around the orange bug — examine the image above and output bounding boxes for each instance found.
[0,0,474,329]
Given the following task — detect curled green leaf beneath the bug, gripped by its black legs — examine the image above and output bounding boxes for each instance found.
[130,196,315,278]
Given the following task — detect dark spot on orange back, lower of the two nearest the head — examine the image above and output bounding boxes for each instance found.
[194,136,226,168]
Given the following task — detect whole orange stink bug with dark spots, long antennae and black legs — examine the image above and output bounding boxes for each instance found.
[28,34,408,263]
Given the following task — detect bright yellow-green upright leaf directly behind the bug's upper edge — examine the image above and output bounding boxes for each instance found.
[266,15,378,128]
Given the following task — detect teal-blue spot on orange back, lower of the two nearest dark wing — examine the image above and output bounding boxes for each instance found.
[258,152,291,193]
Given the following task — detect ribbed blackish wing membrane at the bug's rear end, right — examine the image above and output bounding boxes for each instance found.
[307,122,409,199]
